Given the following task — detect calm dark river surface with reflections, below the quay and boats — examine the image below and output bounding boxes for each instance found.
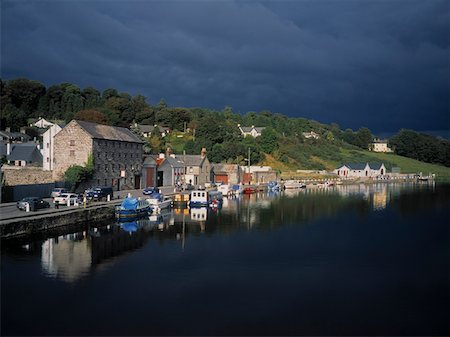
[1,184,450,336]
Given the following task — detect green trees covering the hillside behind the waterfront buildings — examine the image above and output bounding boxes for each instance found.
[0,78,450,169]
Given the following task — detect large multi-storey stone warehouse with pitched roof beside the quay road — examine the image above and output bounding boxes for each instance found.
[53,120,144,190]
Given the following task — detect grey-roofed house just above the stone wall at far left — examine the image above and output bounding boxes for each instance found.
[6,142,42,166]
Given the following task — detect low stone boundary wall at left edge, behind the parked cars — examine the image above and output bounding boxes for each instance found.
[2,165,54,186]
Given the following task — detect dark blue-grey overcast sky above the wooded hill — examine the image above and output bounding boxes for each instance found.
[1,0,450,132]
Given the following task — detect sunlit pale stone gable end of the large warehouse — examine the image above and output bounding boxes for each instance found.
[53,121,93,180]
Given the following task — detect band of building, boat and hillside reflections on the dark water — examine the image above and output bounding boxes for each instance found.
[38,183,434,283]
